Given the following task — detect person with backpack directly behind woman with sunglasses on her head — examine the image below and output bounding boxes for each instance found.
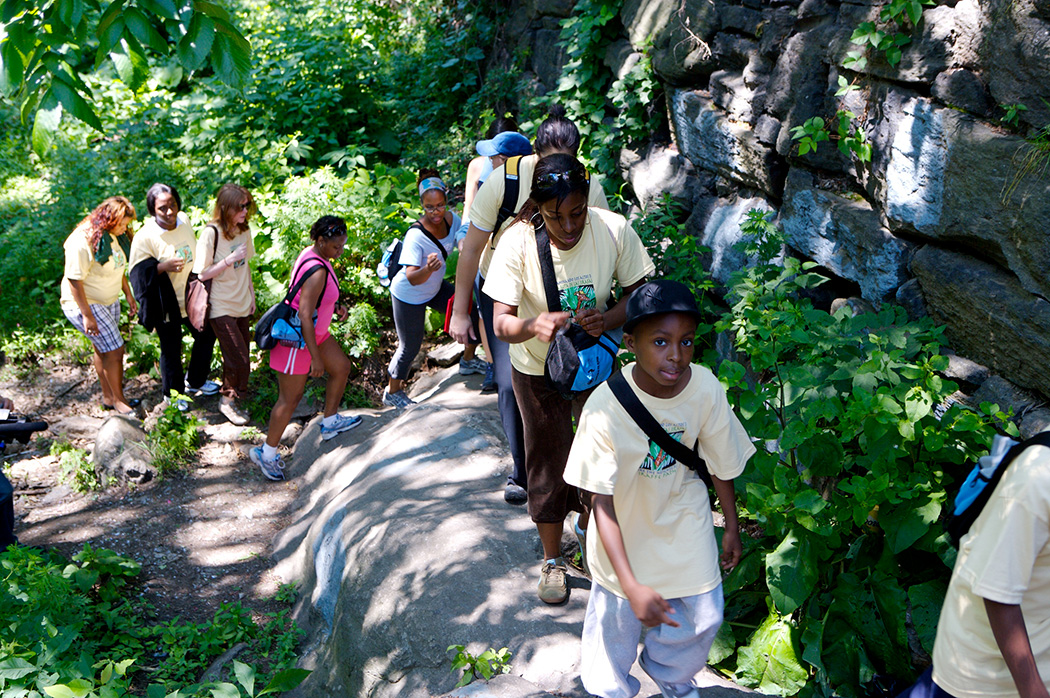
[448,105,609,504]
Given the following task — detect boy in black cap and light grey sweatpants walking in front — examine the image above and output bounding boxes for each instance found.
[565,280,755,698]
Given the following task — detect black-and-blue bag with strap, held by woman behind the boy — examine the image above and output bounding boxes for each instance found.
[536,227,620,399]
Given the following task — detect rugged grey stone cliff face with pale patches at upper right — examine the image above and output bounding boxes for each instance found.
[520,0,1050,396]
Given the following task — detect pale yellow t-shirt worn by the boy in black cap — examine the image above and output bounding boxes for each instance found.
[565,363,755,598]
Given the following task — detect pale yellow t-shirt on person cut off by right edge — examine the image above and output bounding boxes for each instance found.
[933,446,1050,698]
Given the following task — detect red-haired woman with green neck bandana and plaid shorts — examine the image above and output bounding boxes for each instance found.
[62,196,139,415]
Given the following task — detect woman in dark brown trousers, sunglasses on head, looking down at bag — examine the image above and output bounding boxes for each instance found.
[484,153,653,604]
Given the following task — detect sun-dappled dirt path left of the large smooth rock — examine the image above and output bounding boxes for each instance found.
[0,358,298,622]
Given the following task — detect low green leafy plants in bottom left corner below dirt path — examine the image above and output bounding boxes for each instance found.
[0,546,309,698]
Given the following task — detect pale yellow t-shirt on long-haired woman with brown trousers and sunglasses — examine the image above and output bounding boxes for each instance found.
[193,221,255,318]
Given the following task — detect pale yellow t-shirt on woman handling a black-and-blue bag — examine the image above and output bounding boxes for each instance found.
[483,208,654,376]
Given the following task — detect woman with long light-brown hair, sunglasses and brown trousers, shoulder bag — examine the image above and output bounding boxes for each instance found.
[193,184,255,426]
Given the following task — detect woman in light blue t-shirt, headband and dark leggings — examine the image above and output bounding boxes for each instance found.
[383,169,485,408]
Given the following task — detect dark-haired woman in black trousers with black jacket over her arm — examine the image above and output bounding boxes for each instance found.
[128,183,218,411]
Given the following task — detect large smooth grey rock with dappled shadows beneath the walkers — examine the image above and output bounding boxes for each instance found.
[275,367,755,698]
